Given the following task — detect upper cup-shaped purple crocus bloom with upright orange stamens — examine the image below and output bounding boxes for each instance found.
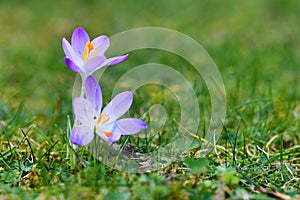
[62,28,128,76]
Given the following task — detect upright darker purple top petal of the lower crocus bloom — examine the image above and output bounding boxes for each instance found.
[85,76,102,115]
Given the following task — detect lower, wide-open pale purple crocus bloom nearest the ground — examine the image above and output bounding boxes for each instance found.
[70,76,147,146]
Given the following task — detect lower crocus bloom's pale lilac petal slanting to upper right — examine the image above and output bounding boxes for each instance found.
[102,91,133,121]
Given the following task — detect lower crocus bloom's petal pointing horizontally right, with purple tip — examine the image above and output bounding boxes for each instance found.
[114,118,147,135]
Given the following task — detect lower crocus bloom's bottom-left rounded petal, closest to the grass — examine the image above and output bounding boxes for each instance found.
[70,126,94,146]
